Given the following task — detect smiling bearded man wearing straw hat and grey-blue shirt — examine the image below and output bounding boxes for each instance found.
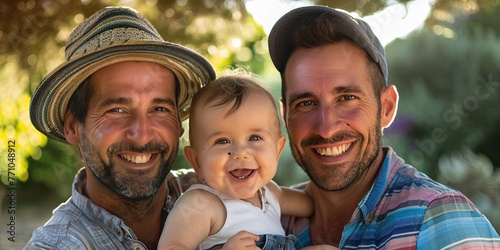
[25,7,215,249]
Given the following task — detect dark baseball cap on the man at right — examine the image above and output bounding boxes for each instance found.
[268,5,388,84]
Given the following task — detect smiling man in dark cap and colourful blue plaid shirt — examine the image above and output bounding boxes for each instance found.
[269,6,500,249]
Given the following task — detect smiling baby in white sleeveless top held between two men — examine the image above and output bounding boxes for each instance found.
[158,71,334,249]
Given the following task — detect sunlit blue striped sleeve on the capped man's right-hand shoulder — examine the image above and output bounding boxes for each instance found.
[417,193,500,249]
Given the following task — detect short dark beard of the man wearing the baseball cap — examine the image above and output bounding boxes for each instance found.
[290,116,382,191]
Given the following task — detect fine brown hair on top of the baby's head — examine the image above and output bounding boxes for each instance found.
[191,70,276,117]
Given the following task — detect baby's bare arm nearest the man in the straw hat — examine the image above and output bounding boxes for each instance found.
[158,190,226,250]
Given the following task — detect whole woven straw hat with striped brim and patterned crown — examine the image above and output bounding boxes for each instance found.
[30,7,215,143]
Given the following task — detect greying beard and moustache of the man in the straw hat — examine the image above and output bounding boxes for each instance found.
[81,133,178,200]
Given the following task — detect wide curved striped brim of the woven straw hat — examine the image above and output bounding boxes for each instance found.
[30,42,215,143]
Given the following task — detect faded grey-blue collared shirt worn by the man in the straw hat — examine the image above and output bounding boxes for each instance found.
[24,169,197,250]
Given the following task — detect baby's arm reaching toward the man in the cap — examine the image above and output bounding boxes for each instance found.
[266,181,314,217]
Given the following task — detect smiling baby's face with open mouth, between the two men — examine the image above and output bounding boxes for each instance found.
[190,91,285,199]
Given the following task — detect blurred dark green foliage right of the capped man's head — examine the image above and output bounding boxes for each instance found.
[386,2,500,177]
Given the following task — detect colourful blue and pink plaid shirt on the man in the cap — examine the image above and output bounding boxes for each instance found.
[282,148,500,249]
